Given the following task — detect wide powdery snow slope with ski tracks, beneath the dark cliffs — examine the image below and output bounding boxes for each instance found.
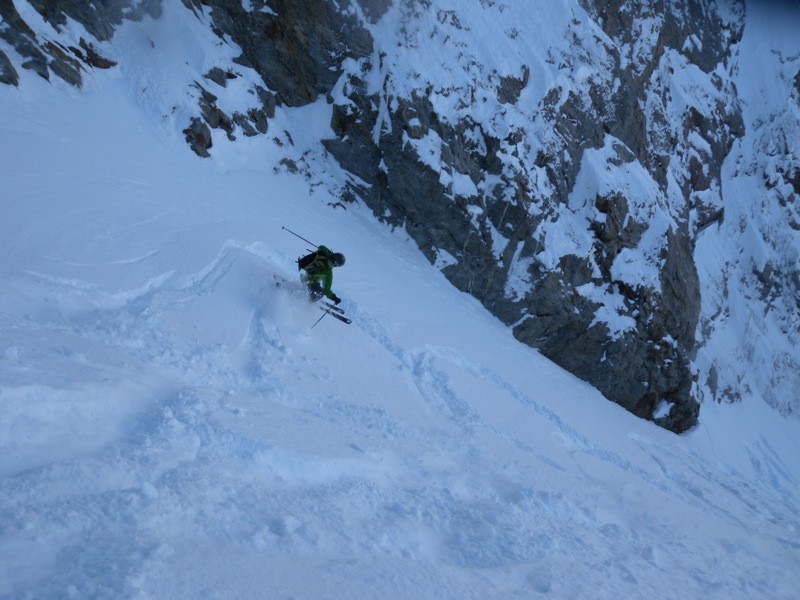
[0,2,800,599]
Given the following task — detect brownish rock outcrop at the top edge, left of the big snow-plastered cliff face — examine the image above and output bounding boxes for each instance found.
[169,0,372,152]
